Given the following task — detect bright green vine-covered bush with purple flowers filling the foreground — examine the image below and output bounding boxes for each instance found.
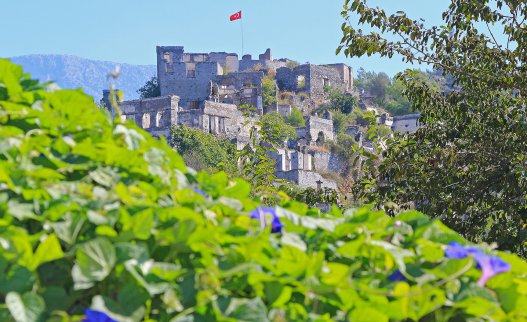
[0,60,527,322]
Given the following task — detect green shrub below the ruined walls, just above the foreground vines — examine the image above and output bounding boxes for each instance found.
[170,126,237,174]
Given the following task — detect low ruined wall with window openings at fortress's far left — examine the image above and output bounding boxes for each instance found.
[120,95,179,138]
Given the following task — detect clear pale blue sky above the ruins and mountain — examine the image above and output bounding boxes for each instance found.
[0,0,449,75]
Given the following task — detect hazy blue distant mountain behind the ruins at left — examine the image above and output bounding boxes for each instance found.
[11,55,156,101]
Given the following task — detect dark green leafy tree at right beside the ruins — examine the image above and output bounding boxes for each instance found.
[339,0,527,256]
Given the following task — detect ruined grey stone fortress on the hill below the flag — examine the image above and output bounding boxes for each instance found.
[102,46,420,189]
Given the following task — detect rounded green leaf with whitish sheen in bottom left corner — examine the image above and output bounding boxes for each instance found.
[5,292,46,322]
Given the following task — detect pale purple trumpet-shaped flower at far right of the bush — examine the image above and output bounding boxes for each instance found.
[445,242,511,287]
